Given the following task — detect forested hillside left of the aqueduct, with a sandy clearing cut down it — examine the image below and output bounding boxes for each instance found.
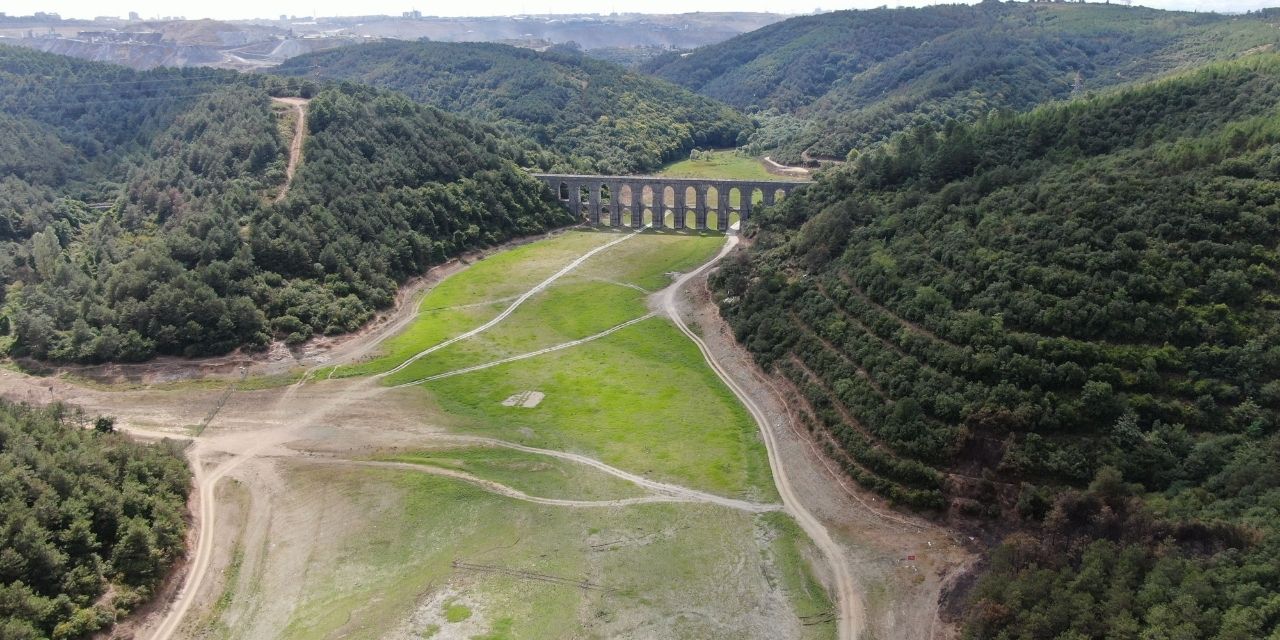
[0,47,572,361]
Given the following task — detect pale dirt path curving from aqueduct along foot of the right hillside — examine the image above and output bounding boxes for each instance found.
[658,233,865,640]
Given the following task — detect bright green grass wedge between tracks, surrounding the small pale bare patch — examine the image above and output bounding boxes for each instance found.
[409,317,776,500]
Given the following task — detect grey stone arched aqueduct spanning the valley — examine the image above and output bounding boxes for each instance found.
[532,173,808,232]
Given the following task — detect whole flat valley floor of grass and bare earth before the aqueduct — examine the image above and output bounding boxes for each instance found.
[0,232,964,639]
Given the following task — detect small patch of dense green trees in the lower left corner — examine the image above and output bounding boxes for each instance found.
[0,401,189,640]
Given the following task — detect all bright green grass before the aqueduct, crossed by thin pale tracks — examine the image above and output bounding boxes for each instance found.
[360,232,776,500]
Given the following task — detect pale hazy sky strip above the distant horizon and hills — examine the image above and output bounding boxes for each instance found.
[0,0,1280,19]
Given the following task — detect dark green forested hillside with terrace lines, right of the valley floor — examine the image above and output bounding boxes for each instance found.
[713,54,1280,640]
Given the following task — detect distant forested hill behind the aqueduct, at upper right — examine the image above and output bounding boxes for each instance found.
[643,0,1280,161]
